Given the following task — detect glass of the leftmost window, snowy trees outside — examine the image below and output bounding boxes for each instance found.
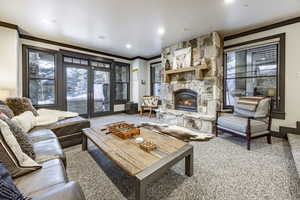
[27,49,56,105]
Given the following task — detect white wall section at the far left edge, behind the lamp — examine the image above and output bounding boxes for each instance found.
[0,27,19,96]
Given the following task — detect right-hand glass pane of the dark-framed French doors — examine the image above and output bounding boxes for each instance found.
[93,70,111,113]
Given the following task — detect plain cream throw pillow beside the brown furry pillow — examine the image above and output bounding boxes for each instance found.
[11,111,37,133]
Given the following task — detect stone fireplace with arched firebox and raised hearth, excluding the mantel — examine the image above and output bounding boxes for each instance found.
[157,32,223,133]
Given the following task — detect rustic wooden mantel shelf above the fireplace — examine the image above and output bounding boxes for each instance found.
[165,65,210,83]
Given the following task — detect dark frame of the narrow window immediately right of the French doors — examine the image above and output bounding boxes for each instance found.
[112,62,131,105]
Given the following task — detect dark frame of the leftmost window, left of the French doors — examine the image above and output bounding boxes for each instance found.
[22,44,59,108]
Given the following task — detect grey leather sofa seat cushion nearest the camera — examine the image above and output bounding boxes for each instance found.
[14,159,68,197]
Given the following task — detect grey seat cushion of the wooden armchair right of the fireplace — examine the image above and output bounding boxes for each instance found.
[218,115,268,136]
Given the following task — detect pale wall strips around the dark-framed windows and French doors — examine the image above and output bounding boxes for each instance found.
[16,39,132,112]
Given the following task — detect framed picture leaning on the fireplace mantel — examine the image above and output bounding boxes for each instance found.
[173,47,192,69]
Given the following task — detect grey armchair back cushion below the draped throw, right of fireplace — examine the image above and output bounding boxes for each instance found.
[234,98,271,118]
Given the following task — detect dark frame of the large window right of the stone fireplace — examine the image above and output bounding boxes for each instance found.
[223,33,286,119]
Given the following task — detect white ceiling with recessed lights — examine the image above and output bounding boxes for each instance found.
[0,0,300,57]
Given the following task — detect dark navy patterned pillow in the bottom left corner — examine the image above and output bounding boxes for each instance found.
[0,162,31,200]
